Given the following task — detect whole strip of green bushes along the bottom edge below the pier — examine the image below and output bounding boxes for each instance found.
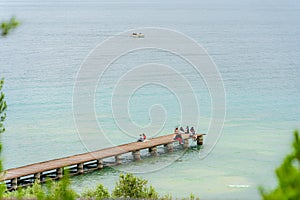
[4,174,199,200]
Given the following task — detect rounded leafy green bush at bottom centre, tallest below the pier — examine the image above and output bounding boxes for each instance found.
[112,173,158,199]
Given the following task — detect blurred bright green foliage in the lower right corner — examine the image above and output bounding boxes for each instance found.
[260,131,300,200]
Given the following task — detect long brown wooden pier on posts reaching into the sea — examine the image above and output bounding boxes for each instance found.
[0,134,205,190]
